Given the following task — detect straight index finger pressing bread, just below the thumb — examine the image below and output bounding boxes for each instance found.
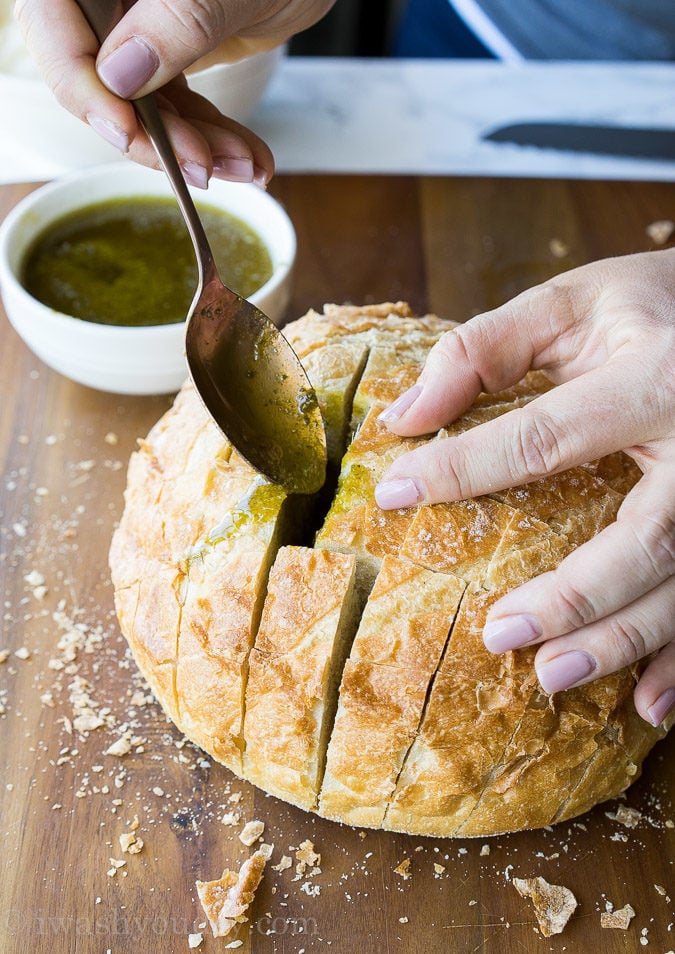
[375,355,672,509]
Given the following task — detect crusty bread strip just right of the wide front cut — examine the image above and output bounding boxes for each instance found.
[319,556,464,827]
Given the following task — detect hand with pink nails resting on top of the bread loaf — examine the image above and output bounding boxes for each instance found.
[375,249,675,725]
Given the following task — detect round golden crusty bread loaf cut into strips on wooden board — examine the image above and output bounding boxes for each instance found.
[111,304,663,836]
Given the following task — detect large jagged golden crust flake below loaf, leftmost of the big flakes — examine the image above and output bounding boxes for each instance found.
[196,846,270,937]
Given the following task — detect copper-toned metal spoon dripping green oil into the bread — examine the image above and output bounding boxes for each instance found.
[77,0,326,494]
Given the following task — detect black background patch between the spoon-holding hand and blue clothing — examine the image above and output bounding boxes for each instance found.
[289,0,404,56]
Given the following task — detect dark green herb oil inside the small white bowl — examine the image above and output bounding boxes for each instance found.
[22,197,272,325]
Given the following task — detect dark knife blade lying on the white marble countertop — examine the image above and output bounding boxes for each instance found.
[481,122,675,162]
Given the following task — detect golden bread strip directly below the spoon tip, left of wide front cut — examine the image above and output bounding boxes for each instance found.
[243,547,358,809]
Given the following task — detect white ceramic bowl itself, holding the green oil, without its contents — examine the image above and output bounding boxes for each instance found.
[0,163,296,394]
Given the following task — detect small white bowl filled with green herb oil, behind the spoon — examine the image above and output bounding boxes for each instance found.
[0,163,296,394]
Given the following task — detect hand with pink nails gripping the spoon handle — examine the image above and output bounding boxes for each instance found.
[15,0,334,189]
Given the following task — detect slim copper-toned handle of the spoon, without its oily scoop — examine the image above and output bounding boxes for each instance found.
[77,0,219,294]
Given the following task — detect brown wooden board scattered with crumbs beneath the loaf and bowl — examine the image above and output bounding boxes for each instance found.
[0,176,675,954]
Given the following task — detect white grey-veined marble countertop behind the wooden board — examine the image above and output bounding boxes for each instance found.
[0,57,675,182]
